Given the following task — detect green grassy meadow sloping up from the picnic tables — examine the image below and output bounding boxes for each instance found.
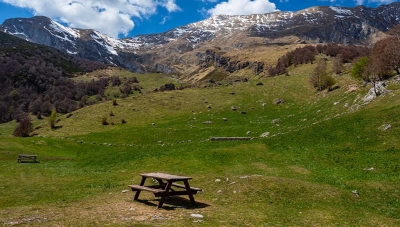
[0,65,400,226]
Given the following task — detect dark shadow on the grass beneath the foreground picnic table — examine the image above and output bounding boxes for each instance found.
[134,196,210,210]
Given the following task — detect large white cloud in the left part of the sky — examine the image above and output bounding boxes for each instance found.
[0,0,180,37]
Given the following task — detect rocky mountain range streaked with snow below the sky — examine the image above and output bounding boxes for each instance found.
[0,3,400,75]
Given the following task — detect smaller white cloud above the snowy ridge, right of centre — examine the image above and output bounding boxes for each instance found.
[208,0,277,16]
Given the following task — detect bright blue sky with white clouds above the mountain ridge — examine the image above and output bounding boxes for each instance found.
[0,0,400,38]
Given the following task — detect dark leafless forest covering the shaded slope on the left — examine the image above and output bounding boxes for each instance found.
[0,32,110,123]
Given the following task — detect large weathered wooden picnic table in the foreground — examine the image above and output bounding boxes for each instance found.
[128,173,201,208]
